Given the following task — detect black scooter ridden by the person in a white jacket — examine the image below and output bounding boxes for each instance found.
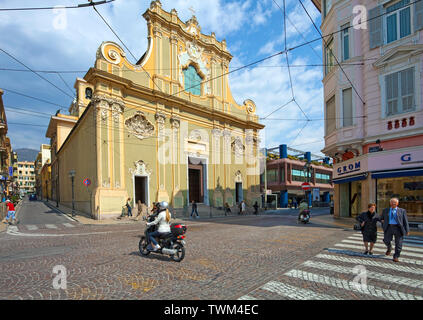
[138,215,187,262]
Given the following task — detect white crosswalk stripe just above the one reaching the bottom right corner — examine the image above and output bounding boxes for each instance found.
[303,261,423,289]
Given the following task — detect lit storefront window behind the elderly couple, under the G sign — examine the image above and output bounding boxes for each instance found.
[377,177,423,216]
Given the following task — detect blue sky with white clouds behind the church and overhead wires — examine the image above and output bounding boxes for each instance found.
[0,0,324,154]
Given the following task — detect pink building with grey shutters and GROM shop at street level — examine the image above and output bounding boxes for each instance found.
[312,0,423,218]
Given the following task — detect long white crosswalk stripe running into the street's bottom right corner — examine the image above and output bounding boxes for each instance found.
[285,269,423,300]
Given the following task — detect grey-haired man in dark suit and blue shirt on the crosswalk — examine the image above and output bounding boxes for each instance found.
[381,198,410,262]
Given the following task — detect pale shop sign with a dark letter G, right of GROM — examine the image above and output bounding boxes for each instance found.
[369,148,423,171]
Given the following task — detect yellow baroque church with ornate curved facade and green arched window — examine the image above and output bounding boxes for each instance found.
[47,1,264,219]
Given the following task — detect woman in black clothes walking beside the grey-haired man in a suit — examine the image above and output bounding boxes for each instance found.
[357,203,380,255]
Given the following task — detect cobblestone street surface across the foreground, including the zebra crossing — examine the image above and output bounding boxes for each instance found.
[0,206,423,300]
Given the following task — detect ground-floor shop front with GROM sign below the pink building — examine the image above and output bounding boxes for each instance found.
[333,146,423,218]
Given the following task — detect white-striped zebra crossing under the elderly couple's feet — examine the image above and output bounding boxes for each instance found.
[238,232,423,300]
